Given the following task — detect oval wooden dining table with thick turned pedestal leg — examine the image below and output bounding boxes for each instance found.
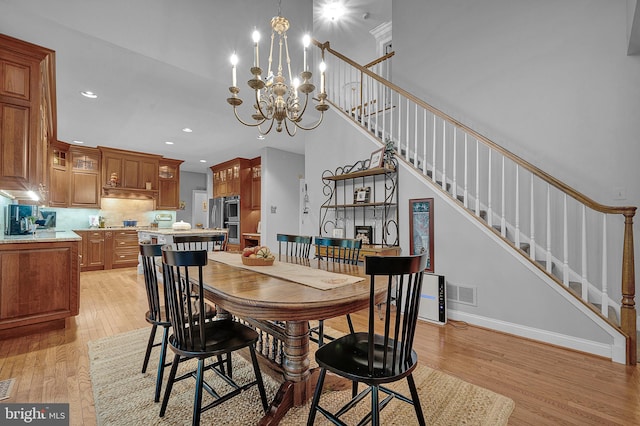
[198,255,386,425]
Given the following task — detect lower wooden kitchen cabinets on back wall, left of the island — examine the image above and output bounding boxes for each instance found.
[74,229,139,272]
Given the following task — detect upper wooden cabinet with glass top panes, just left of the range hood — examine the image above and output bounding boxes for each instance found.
[69,146,101,208]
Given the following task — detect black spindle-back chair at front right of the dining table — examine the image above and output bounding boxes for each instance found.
[307,254,427,426]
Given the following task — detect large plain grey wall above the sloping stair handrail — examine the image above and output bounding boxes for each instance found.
[393,0,640,282]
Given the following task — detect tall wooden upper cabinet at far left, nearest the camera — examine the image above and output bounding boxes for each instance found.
[0,34,56,191]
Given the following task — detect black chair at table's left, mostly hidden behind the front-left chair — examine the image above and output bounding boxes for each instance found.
[140,244,171,402]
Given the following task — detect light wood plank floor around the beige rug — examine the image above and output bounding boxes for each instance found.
[0,268,640,425]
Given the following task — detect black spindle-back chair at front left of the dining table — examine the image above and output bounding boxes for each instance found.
[160,245,268,425]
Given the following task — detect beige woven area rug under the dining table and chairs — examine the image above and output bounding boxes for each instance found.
[89,328,515,426]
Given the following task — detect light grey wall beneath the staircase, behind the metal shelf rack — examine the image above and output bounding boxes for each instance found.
[302,111,614,356]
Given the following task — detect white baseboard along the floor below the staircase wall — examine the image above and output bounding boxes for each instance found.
[447,309,626,364]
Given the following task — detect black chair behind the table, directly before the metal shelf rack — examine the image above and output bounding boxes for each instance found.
[310,237,362,346]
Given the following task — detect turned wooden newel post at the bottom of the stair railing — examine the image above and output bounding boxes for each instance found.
[620,208,638,365]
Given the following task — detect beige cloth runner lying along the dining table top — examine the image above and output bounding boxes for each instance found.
[209,251,364,290]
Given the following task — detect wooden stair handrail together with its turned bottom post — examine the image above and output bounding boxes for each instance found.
[313,39,637,365]
